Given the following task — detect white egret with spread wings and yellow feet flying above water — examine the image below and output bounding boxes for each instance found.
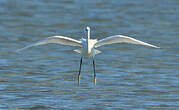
[17,27,160,84]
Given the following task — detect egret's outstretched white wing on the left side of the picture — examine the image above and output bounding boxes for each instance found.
[16,36,82,52]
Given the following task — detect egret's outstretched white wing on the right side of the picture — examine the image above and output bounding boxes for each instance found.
[95,35,160,48]
